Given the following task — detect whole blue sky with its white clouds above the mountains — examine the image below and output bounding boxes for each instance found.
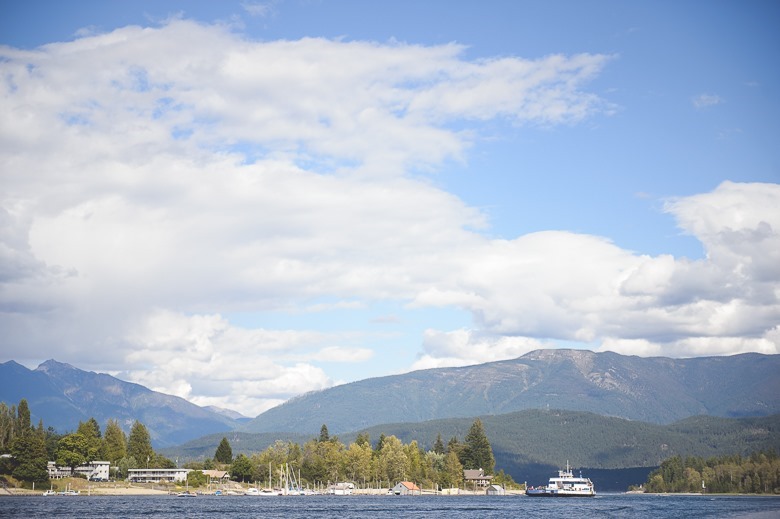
[0,0,780,416]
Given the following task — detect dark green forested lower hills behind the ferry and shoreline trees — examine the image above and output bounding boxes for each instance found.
[162,409,780,491]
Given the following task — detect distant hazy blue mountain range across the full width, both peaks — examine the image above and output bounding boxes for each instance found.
[0,349,780,447]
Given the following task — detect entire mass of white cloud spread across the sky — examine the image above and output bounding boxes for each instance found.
[0,20,780,414]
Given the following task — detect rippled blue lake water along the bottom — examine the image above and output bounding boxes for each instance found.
[0,494,780,519]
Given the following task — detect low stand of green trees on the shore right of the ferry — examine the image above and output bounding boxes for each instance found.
[645,450,780,494]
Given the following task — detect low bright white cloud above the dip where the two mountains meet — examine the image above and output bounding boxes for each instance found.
[119,310,362,416]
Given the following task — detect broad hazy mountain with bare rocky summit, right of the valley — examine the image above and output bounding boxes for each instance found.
[241,350,780,433]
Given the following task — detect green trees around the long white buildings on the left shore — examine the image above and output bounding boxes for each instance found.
[0,399,175,483]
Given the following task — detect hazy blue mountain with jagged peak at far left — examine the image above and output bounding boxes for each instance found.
[0,360,237,446]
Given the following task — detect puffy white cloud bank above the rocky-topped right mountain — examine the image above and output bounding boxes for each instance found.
[408,182,780,365]
